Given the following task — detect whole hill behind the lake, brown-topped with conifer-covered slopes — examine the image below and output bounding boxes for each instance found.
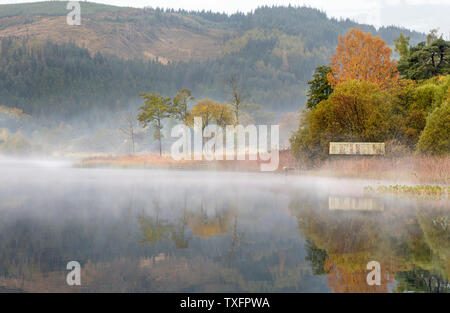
[0,2,425,117]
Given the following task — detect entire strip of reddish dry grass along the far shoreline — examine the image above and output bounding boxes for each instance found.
[79,150,450,185]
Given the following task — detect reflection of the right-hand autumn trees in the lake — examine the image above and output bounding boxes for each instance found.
[290,196,450,292]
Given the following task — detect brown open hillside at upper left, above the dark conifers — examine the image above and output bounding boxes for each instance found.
[0,2,229,63]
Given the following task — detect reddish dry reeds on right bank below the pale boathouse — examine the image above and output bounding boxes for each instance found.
[314,156,450,185]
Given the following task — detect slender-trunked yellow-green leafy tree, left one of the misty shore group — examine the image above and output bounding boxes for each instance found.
[138,92,173,156]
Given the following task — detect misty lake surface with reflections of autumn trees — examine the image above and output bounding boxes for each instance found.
[0,161,450,292]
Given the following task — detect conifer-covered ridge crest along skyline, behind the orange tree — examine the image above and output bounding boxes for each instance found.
[152,5,424,48]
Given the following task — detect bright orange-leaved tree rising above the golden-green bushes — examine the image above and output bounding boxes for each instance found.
[327,28,399,89]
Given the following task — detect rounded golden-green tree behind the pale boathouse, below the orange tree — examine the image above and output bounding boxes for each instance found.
[291,80,401,159]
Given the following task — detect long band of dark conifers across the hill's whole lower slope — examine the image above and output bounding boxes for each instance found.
[0,38,309,118]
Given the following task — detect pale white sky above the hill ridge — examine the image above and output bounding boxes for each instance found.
[0,0,450,35]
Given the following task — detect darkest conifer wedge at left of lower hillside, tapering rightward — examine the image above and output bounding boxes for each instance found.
[0,38,188,118]
